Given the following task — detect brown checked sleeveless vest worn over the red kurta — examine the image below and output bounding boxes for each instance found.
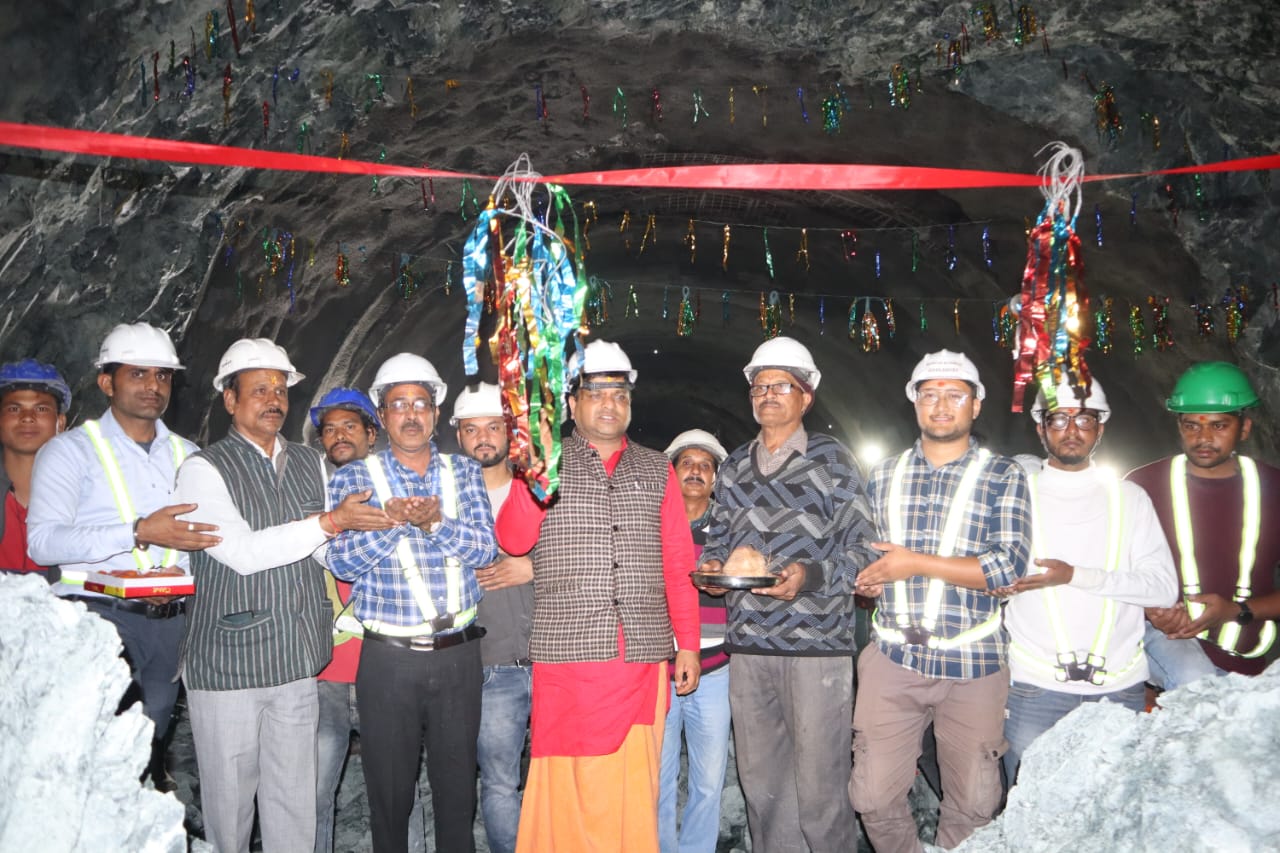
[530,432,675,663]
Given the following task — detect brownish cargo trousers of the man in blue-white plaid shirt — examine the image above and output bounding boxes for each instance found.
[849,644,1009,853]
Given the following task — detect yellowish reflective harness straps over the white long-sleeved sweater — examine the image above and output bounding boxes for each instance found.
[1009,469,1143,686]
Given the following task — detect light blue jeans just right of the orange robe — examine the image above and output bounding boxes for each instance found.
[658,666,731,853]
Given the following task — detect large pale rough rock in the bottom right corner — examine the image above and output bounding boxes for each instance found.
[956,665,1280,853]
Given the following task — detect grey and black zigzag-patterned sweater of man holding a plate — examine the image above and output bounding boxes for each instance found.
[701,433,878,657]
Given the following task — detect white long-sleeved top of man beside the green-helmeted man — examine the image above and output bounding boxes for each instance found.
[1005,459,1178,695]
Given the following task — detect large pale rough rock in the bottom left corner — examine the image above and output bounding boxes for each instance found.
[0,576,187,853]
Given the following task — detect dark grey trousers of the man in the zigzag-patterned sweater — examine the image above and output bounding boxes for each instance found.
[728,653,858,853]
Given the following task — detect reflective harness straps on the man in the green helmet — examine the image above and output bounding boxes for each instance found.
[1169,455,1276,657]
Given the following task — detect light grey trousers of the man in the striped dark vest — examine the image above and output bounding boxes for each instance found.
[187,679,319,853]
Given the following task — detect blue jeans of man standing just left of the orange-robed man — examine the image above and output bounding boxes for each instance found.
[476,663,532,853]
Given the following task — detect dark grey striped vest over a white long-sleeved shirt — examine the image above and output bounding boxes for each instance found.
[182,433,333,690]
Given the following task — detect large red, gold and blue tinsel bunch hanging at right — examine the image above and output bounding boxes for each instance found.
[1012,142,1093,412]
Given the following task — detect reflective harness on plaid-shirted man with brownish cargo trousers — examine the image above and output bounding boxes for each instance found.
[872,448,1000,651]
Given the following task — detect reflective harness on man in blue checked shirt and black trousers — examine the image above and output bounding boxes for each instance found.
[364,453,476,637]
